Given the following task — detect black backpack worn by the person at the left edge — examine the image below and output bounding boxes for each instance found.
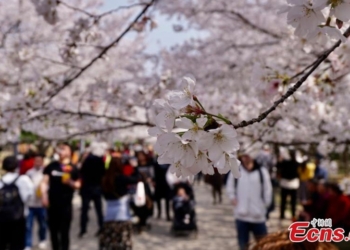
[0,176,24,222]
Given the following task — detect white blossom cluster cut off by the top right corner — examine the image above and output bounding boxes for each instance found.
[281,0,350,42]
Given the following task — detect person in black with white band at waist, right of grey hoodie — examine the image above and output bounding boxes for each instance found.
[277,150,300,221]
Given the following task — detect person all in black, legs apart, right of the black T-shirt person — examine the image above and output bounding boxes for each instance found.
[79,148,105,238]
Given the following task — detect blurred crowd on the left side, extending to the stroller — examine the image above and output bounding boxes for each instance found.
[0,143,196,250]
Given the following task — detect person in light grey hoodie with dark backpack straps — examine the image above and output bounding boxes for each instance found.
[226,155,272,250]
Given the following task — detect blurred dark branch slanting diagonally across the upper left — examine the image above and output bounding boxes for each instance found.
[43,0,156,106]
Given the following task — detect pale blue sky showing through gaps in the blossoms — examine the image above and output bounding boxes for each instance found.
[102,0,198,52]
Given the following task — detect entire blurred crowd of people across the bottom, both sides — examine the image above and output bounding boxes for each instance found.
[0,143,350,250]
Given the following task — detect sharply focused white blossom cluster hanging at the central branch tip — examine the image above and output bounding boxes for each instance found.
[149,77,240,178]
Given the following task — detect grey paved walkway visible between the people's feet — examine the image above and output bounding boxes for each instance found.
[33,184,289,250]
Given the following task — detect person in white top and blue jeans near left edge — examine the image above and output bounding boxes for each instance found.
[25,155,47,250]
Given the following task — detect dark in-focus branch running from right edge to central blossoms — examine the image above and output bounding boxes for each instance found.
[233,27,350,128]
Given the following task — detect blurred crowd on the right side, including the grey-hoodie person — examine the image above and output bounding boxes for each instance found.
[221,146,350,250]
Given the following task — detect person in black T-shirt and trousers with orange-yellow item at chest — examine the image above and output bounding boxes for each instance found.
[42,144,80,250]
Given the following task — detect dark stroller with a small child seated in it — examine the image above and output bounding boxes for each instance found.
[171,182,198,237]
